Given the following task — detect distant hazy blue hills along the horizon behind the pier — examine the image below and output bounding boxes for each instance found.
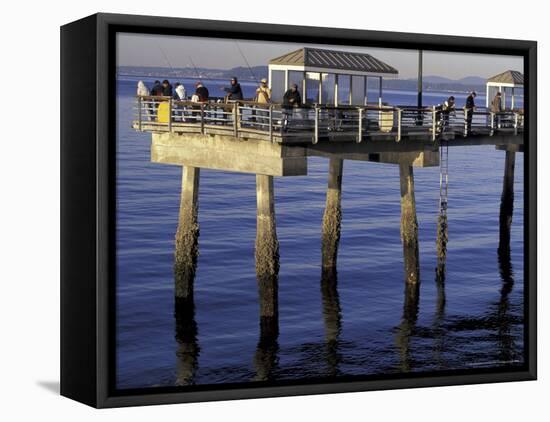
[117,66,485,92]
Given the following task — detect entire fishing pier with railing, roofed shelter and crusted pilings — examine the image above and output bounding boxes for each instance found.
[132,49,524,362]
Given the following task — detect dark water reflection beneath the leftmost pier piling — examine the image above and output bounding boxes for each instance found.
[174,297,200,385]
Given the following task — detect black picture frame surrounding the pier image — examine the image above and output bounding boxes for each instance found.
[61,13,537,408]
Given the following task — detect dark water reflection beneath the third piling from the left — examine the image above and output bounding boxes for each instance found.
[321,268,342,376]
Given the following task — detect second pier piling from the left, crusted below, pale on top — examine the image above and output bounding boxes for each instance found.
[256,174,279,337]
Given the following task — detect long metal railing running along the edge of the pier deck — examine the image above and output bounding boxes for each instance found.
[133,96,524,143]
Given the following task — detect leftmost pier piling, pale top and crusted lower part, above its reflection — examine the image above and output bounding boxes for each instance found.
[174,166,200,299]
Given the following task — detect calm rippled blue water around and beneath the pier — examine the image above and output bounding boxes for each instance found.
[116,80,523,388]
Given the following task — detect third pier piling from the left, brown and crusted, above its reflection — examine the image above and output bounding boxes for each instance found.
[321,158,344,271]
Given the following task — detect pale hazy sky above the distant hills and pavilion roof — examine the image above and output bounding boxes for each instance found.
[117,34,523,79]
